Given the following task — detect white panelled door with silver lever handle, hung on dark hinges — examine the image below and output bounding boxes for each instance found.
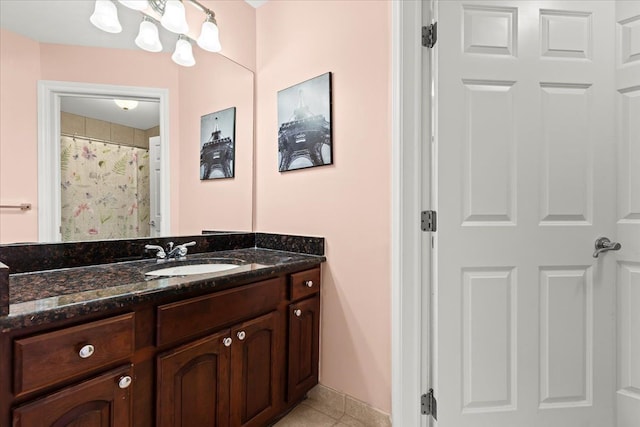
[433,0,640,427]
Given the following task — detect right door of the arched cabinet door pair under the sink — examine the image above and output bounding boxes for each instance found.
[231,311,284,427]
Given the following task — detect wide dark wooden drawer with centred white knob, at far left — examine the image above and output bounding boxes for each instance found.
[13,313,134,396]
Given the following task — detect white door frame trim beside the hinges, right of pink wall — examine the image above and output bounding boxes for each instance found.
[391,1,432,426]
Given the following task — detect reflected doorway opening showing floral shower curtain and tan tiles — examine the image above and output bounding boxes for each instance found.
[59,96,161,242]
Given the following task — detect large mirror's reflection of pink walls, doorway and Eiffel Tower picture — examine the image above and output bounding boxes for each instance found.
[0,0,254,243]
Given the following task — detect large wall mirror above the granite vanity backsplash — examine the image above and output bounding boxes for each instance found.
[0,0,254,243]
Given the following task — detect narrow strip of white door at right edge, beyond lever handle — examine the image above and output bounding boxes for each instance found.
[615,1,640,427]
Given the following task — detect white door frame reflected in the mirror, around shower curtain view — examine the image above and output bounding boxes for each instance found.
[38,80,171,242]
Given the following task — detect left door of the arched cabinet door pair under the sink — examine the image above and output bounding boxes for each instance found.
[157,329,231,427]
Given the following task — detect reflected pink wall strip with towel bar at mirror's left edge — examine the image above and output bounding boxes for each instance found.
[0,30,40,242]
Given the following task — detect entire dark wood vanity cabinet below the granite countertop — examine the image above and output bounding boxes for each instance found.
[0,268,320,427]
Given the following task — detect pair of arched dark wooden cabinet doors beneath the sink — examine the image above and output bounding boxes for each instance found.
[157,311,283,427]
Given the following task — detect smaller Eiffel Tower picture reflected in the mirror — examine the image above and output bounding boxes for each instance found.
[200,107,236,180]
